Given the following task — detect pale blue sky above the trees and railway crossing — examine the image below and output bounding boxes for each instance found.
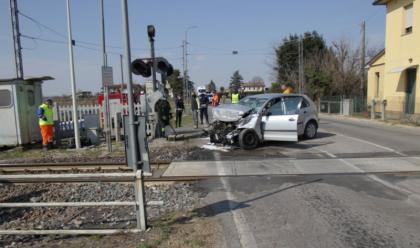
[0,0,385,95]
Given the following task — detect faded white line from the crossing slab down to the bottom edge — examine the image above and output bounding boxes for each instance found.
[214,153,258,248]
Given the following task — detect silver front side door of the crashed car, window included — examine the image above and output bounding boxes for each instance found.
[262,98,301,141]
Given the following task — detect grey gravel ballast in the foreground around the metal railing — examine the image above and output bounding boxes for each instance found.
[0,183,201,247]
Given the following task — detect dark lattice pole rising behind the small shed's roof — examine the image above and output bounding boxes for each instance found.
[10,0,23,79]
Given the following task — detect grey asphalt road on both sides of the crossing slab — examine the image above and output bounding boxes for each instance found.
[193,116,420,248]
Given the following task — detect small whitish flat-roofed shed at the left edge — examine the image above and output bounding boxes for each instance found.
[0,76,54,146]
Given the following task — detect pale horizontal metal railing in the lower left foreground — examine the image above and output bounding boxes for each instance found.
[0,170,146,235]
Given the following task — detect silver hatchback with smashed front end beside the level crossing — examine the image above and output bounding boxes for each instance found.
[208,94,319,149]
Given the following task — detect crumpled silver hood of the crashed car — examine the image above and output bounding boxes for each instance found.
[213,104,252,122]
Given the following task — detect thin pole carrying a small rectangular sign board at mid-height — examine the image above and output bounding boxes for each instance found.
[100,0,112,152]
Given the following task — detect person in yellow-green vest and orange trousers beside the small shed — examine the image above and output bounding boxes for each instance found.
[37,99,54,150]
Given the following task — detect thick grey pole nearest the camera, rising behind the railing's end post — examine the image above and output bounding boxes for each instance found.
[121,0,139,171]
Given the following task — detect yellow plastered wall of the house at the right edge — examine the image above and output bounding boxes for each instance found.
[384,0,420,116]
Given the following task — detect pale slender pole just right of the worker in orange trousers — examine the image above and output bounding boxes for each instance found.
[67,0,80,149]
